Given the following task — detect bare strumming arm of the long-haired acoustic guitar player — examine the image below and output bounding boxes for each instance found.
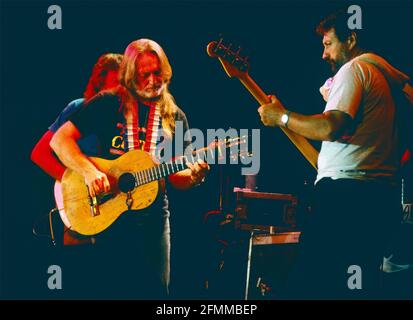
[50,121,110,196]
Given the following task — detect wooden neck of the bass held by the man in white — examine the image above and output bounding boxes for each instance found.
[239,73,318,170]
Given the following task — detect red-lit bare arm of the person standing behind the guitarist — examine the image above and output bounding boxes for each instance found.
[30,130,66,181]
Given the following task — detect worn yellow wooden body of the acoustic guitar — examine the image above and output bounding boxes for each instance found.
[61,150,159,235]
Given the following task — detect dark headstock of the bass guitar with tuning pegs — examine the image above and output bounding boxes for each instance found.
[207,38,249,78]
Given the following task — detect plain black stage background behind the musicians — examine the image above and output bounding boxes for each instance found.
[0,1,413,299]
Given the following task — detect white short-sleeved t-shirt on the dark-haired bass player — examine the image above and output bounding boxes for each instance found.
[316,54,408,183]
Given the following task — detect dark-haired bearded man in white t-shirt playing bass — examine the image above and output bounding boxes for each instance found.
[259,11,411,299]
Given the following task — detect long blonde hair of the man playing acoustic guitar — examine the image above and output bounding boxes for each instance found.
[119,39,178,134]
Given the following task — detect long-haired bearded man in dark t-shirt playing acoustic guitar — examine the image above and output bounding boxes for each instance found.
[51,39,209,299]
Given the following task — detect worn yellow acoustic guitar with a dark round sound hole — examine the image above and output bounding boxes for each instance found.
[54,136,247,235]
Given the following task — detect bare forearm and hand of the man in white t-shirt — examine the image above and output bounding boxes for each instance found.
[258,96,352,141]
